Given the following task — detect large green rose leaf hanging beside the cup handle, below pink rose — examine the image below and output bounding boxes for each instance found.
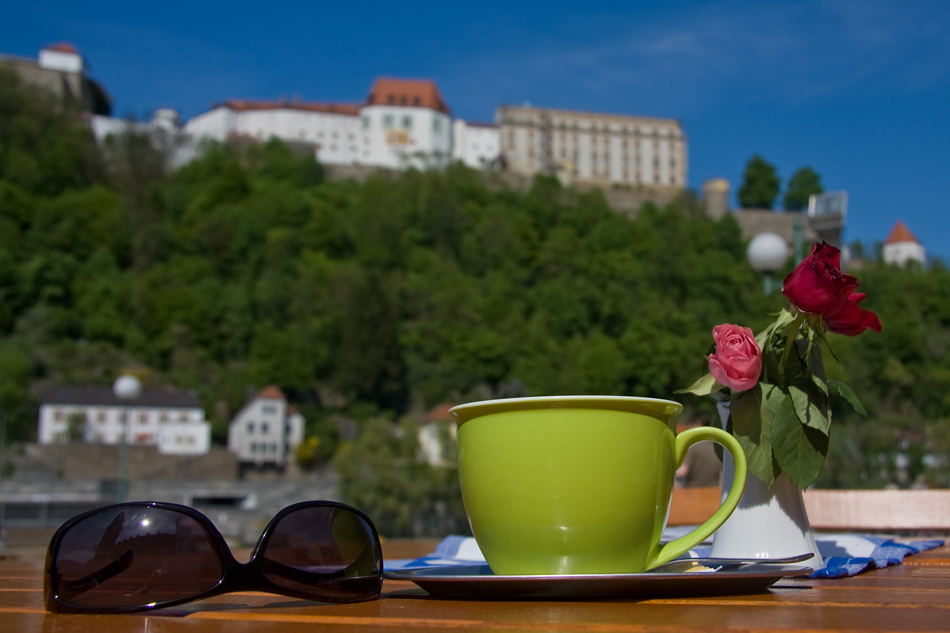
[729,383,784,485]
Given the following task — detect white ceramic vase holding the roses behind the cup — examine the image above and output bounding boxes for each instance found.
[711,404,824,569]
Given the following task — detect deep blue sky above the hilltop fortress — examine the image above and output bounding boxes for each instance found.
[7,0,950,260]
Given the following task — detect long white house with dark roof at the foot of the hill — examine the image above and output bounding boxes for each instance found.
[38,386,211,455]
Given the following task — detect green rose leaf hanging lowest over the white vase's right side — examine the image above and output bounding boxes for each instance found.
[772,398,828,489]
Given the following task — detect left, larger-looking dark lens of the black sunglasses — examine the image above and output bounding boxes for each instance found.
[51,505,224,608]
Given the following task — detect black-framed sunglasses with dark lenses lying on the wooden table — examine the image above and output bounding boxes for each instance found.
[43,501,383,613]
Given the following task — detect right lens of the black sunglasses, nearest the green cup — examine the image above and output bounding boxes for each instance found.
[261,506,383,602]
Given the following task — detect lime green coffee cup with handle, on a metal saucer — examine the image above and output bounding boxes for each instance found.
[451,396,746,575]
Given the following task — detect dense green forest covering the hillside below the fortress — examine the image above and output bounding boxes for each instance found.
[0,72,950,532]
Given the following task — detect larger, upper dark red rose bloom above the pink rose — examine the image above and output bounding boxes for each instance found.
[782,242,858,317]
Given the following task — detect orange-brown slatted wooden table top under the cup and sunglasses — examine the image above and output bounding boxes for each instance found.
[0,541,950,633]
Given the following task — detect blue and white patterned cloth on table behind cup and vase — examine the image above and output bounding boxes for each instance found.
[384,534,944,578]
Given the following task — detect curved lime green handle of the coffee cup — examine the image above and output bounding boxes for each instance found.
[646,426,746,569]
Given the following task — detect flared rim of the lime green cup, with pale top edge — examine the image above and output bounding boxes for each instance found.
[449,396,683,424]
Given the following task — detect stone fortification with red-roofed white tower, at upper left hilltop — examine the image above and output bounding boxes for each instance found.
[0,42,112,116]
